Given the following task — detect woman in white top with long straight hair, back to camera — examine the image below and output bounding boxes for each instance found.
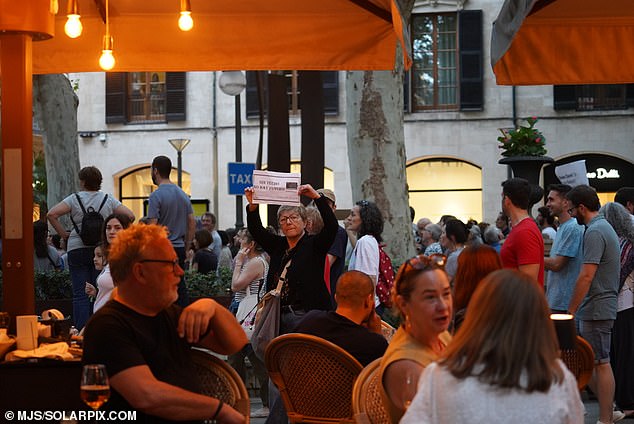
[401,269,583,424]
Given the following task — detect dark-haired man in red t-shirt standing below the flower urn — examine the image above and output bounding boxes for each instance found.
[500,178,544,287]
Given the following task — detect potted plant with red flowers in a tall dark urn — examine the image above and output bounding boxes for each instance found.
[498,116,554,213]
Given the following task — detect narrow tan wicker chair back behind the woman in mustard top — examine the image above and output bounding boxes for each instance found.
[352,358,390,424]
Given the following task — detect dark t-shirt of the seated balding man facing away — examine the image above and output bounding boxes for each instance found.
[295,310,387,366]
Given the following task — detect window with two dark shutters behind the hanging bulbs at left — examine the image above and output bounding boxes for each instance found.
[106,72,186,124]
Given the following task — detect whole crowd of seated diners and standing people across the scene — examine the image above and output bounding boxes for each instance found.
[34,161,634,423]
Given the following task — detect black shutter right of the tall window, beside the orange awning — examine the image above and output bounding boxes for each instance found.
[458,10,484,110]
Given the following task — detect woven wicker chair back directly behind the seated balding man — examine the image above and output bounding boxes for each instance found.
[264,333,362,423]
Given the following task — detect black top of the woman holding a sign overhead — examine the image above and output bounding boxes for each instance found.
[247,196,339,311]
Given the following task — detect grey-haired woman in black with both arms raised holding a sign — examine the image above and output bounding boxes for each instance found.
[244,184,337,334]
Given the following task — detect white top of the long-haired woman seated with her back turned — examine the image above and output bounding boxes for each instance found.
[401,361,583,424]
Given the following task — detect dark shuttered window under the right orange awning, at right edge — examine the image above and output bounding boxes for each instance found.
[553,84,634,111]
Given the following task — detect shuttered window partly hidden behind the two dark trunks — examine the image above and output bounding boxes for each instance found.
[246,71,339,118]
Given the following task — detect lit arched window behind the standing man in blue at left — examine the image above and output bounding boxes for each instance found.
[119,166,191,219]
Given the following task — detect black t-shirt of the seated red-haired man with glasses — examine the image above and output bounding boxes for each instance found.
[82,300,200,423]
